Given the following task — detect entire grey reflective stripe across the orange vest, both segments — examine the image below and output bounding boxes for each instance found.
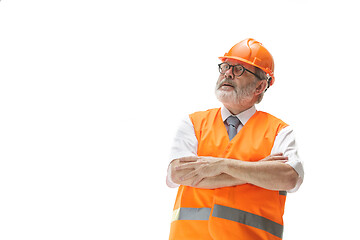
[171,204,284,238]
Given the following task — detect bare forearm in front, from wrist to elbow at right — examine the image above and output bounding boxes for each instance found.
[224,159,298,190]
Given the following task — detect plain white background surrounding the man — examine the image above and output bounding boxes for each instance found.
[0,0,360,240]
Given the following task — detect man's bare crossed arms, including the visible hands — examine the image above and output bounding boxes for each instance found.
[170,153,299,191]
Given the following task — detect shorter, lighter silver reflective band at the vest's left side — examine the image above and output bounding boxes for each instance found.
[171,208,211,222]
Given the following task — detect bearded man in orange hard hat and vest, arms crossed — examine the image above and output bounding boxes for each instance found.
[167,39,304,240]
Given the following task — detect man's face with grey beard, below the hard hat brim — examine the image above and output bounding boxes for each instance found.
[215,59,257,104]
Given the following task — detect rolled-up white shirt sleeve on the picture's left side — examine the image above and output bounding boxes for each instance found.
[166,116,198,188]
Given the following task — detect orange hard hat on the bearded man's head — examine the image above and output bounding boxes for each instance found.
[219,38,275,86]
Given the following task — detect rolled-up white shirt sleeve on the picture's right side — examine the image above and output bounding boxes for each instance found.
[271,126,304,193]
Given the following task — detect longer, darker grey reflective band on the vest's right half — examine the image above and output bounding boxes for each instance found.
[212,204,284,238]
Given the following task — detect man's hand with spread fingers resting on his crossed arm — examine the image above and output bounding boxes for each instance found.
[175,157,226,187]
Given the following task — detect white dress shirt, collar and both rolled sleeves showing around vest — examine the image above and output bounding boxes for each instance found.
[166,106,304,192]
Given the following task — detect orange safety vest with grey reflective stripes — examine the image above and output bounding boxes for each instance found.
[169,108,287,240]
